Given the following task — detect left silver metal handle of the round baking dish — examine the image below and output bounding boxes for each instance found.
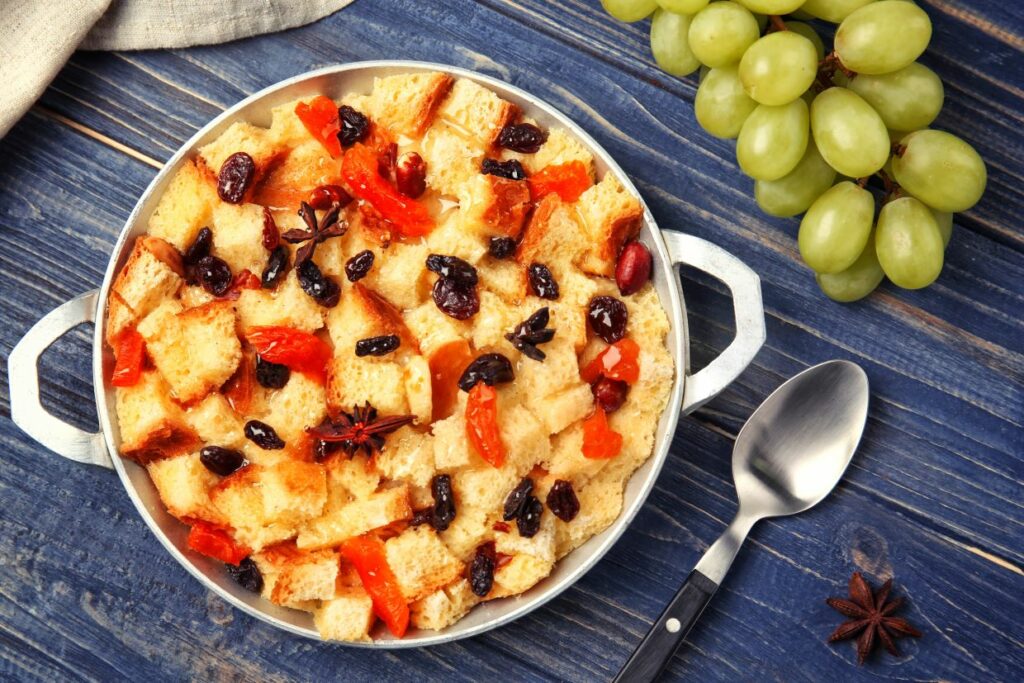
[7,290,114,469]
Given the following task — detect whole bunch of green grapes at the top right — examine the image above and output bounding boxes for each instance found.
[601,0,986,301]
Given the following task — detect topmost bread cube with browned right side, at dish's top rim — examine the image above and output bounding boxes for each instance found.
[367,73,453,137]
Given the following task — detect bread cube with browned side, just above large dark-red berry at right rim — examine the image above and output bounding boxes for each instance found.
[577,173,643,278]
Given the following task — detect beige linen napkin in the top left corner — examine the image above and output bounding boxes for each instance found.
[0,0,352,137]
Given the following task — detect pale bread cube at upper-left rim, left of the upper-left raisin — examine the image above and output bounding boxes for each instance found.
[150,159,219,253]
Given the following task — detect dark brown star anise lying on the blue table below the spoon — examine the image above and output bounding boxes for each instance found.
[825,571,922,665]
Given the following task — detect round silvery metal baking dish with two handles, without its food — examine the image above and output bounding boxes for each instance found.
[8,61,765,648]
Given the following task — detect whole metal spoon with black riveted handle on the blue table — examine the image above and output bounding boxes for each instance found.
[614,360,868,683]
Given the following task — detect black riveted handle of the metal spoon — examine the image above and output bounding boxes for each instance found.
[614,569,718,683]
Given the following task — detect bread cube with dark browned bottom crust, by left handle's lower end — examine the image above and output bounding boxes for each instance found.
[116,371,199,465]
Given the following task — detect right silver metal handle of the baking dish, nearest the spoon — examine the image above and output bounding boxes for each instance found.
[662,230,765,413]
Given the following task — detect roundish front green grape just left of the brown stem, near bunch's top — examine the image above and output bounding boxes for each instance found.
[739,31,818,104]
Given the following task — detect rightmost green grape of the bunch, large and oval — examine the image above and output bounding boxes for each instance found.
[893,130,987,212]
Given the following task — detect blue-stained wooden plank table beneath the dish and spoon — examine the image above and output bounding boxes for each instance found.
[0,0,1024,681]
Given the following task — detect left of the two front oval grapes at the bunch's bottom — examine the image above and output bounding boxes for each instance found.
[797,180,874,272]
